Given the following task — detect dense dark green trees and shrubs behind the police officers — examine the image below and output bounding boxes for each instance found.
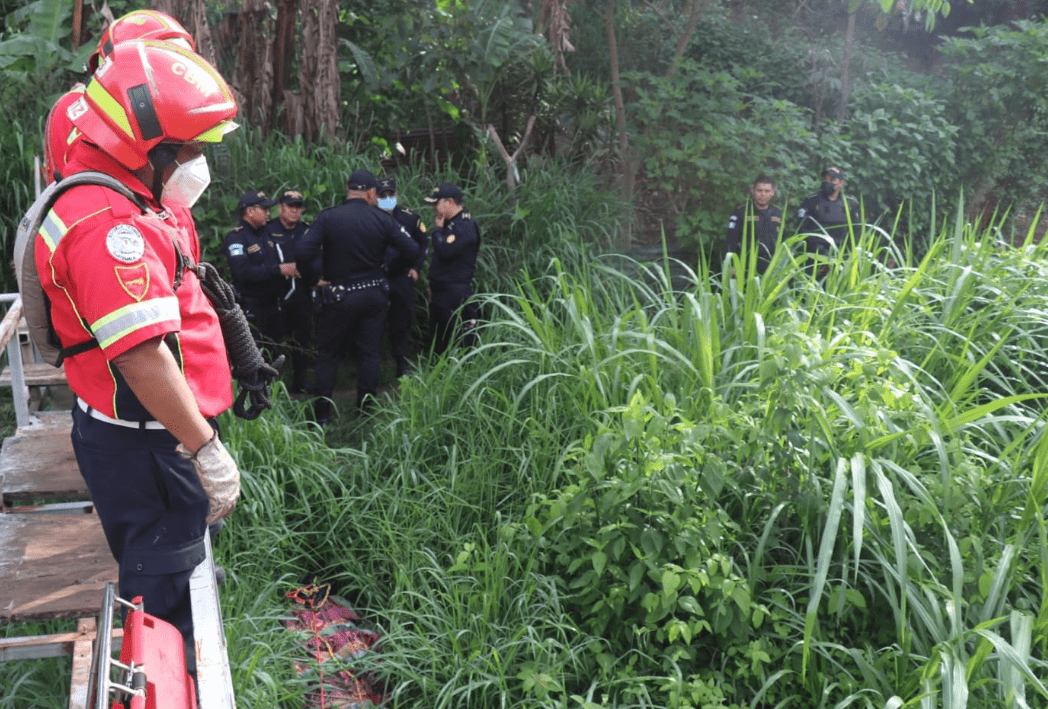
[0,0,1048,278]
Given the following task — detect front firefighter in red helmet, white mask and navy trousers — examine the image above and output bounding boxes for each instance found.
[35,41,239,661]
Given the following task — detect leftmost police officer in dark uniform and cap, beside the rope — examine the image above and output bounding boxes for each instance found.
[225,192,296,347]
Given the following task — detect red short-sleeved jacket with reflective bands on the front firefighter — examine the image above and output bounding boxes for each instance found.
[35,141,233,421]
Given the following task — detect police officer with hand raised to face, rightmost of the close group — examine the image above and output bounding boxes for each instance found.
[425,182,480,354]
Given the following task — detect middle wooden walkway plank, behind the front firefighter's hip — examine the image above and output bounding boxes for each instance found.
[0,412,90,508]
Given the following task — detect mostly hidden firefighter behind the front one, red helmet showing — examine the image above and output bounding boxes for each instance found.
[44,9,196,184]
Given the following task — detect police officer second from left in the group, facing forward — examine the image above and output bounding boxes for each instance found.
[262,190,313,394]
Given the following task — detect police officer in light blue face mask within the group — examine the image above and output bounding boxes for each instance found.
[378,177,430,377]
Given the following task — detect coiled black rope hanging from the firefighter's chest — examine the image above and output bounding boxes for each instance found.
[193,262,284,421]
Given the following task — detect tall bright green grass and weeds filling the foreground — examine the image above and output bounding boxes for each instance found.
[8,129,1048,709]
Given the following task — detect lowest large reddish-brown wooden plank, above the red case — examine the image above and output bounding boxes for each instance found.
[0,514,117,622]
